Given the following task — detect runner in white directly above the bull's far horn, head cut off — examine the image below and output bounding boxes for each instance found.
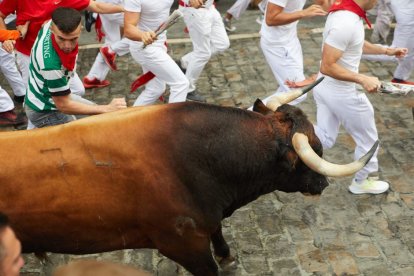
[260,0,328,109]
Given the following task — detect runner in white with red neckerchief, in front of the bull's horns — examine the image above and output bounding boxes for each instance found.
[313,0,407,194]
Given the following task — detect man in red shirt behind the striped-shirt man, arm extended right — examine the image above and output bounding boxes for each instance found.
[0,0,124,95]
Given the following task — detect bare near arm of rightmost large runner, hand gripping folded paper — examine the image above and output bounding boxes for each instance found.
[321,43,381,93]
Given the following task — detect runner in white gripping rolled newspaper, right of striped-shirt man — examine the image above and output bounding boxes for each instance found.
[124,0,188,106]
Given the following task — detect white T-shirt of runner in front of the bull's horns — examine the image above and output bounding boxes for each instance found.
[322,10,365,87]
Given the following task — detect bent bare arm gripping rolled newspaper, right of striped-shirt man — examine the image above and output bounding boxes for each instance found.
[124,11,156,45]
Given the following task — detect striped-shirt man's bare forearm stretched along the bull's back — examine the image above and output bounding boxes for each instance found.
[52,95,126,115]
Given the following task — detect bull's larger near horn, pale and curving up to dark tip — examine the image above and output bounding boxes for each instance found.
[292,132,379,177]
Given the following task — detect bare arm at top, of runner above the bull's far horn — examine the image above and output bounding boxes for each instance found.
[266,3,326,26]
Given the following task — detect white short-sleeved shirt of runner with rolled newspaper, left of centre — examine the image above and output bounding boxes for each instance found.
[124,0,174,40]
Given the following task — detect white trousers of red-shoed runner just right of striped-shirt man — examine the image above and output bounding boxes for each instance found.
[87,13,129,81]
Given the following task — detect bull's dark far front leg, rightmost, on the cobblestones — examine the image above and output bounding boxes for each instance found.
[211,223,237,270]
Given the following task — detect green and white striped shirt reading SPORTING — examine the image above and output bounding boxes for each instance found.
[25,20,73,112]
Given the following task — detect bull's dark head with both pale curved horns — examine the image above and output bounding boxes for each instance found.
[253,78,379,194]
